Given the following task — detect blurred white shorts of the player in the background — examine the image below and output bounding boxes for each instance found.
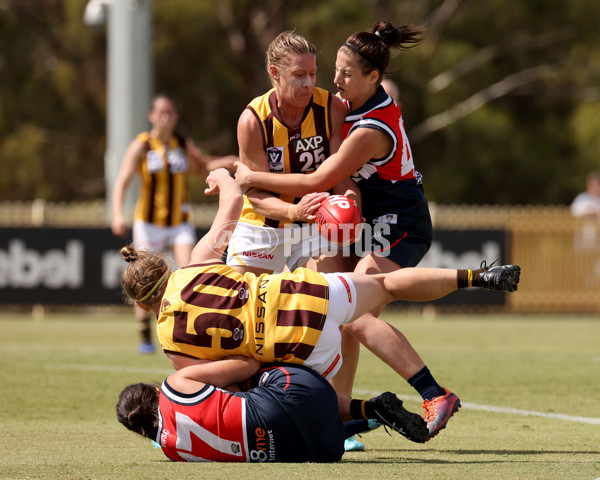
[133,220,196,252]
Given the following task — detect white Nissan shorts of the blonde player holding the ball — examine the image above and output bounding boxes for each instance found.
[227,222,337,273]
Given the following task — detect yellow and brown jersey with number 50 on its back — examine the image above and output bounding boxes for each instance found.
[157,263,329,363]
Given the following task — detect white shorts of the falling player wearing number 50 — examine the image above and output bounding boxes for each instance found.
[304,273,356,380]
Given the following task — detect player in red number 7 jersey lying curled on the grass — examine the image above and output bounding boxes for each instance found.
[117,357,436,462]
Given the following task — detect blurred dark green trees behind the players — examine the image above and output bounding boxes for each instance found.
[0,0,600,204]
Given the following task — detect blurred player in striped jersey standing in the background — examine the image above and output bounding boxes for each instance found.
[111,93,237,353]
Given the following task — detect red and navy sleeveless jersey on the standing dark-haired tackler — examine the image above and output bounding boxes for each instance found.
[342,87,421,182]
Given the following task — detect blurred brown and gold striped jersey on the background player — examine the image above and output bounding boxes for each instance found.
[135,132,190,227]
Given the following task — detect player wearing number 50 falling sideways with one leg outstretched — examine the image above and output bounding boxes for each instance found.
[121,169,520,446]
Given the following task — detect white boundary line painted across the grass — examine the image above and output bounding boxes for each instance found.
[46,363,600,428]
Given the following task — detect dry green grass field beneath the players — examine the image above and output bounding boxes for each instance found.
[0,310,600,480]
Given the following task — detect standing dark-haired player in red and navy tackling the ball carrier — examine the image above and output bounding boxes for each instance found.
[236,21,460,437]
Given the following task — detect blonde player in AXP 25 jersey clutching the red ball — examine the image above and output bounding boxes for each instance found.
[227,32,358,274]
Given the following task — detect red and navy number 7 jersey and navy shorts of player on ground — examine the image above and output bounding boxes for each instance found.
[156,364,344,462]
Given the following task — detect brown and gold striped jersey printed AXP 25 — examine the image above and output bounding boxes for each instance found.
[240,88,332,228]
